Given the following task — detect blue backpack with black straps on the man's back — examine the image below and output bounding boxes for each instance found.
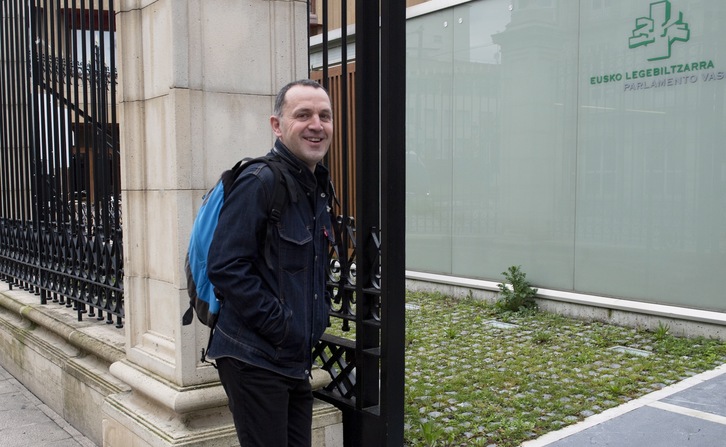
[182,156,296,334]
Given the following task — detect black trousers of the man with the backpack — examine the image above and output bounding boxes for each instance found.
[217,357,313,447]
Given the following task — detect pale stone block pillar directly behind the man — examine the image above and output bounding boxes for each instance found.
[103,0,344,447]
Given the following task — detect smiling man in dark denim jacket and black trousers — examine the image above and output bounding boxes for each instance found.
[208,80,333,447]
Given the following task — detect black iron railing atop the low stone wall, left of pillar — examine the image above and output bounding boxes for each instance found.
[0,0,124,327]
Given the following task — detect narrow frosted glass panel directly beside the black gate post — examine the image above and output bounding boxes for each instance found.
[406,9,453,273]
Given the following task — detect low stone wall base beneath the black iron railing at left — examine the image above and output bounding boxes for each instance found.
[0,286,129,445]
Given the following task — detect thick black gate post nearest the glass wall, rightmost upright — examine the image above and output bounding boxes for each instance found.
[380,0,406,447]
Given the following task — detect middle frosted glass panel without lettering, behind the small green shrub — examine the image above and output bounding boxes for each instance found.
[453,0,578,289]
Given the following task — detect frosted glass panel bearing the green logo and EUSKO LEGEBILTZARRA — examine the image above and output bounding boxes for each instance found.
[575,1,726,310]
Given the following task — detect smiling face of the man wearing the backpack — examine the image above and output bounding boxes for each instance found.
[270,85,333,170]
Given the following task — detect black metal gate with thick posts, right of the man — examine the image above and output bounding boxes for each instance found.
[313,0,406,447]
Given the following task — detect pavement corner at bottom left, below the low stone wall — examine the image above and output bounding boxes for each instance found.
[0,366,97,447]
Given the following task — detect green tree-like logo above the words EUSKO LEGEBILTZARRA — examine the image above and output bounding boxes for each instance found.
[629,0,691,61]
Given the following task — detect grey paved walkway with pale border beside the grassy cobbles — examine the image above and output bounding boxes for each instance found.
[522,365,726,447]
